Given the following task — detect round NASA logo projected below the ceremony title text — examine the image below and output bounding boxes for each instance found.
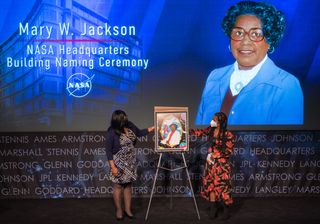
[67,73,94,98]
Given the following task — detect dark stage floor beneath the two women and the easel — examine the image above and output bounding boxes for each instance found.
[0,197,320,224]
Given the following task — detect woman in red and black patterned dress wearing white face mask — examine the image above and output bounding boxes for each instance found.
[191,112,234,219]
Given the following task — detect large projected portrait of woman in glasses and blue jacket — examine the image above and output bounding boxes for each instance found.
[196,1,304,125]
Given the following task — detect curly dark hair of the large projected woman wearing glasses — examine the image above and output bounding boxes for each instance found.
[221,1,286,52]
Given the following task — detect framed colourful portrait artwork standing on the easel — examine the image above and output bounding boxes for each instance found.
[154,106,189,152]
